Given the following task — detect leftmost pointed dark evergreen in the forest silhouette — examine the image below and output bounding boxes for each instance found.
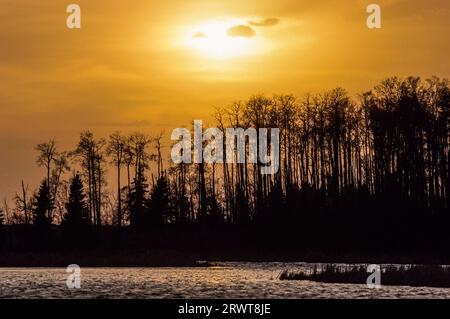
[33,180,55,227]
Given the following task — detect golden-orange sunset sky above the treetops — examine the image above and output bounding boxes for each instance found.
[0,0,450,199]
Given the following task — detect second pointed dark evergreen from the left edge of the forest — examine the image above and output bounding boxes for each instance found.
[62,174,91,231]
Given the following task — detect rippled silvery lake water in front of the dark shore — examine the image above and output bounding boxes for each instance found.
[0,262,450,299]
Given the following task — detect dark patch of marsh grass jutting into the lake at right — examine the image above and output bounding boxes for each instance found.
[279,265,450,288]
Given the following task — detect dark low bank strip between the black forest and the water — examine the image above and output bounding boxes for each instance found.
[0,250,450,268]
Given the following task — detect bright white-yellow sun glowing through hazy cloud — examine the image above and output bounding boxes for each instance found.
[186,20,257,59]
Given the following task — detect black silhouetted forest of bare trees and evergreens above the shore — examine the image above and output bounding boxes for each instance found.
[0,77,450,260]
